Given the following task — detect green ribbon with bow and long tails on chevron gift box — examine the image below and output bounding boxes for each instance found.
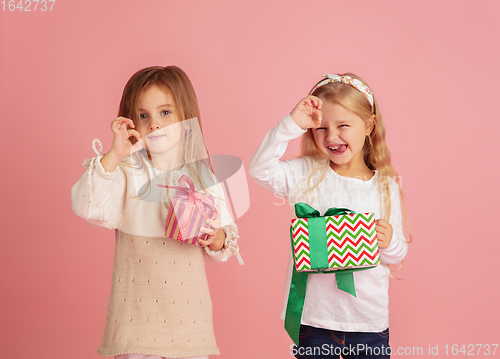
[285,202,370,345]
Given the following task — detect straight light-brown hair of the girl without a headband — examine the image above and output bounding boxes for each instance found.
[118,66,217,198]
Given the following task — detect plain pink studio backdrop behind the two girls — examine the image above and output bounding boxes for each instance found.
[0,0,500,359]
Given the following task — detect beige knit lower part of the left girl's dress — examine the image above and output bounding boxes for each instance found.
[98,231,219,357]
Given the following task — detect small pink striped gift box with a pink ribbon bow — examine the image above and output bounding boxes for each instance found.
[158,175,218,246]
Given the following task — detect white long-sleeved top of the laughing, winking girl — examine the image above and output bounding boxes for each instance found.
[249,115,407,332]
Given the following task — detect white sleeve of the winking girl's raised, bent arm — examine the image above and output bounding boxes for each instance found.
[249,115,307,197]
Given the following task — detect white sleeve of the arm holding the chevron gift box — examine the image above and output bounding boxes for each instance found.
[380,179,408,264]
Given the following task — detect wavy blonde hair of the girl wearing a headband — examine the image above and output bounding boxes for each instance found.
[300,73,412,268]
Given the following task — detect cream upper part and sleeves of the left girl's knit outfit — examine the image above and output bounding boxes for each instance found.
[71,150,243,264]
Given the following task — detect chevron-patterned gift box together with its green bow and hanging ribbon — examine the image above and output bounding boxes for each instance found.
[285,202,380,345]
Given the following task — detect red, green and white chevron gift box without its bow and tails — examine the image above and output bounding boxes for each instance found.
[291,213,380,272]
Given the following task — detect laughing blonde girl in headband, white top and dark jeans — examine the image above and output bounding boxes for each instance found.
[250,73,408,358]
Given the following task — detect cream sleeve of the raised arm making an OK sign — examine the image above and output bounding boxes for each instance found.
[71,156,127,229]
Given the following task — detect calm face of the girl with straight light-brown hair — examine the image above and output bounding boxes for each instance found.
[136,85,182,155]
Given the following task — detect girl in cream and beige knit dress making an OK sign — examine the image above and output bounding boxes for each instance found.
[71,66,242,359]
